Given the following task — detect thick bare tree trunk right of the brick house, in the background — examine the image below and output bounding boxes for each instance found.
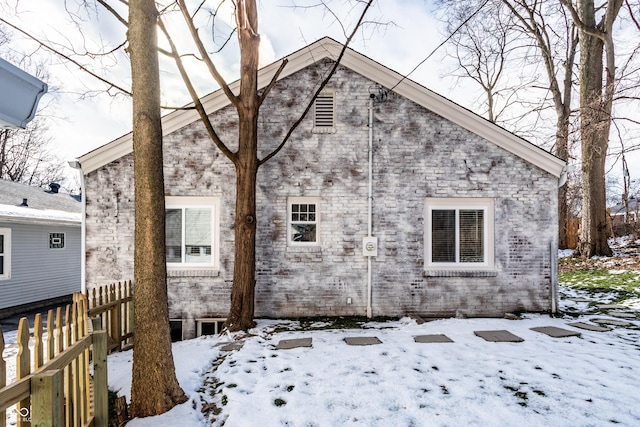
[578,0,615,258]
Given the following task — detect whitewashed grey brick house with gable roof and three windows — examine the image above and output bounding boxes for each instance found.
[79,38,565,337]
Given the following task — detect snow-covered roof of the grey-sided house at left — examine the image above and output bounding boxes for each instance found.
[0,180,82,225]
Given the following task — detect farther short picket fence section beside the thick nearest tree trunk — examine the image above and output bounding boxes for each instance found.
[86,280,133,352]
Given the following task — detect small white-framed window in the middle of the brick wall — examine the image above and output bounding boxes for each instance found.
[288,197,320,246]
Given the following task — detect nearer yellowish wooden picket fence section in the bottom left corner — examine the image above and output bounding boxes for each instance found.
[0,294,108,427]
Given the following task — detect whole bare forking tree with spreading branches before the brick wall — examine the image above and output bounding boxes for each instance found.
[160,0,373,331]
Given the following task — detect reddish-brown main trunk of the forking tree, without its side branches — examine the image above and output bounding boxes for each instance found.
[225,0,260,331]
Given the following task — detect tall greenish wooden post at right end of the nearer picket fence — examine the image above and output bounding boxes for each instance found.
[91,317,109,427]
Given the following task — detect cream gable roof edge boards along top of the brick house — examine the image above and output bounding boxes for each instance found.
[78,37,565,177]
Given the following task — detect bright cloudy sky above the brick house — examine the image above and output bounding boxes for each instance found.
[0,0,640,194]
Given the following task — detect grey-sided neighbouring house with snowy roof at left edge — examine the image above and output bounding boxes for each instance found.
[0,180,82,317]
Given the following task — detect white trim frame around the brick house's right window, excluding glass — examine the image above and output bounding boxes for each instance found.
[424,197,495,270]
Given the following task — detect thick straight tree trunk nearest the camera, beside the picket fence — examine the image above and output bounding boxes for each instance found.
[127,0,187,417]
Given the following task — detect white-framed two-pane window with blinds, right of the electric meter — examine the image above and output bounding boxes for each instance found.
[425,198,493,270]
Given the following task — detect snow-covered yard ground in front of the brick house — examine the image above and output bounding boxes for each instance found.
[5,289,640,427]
